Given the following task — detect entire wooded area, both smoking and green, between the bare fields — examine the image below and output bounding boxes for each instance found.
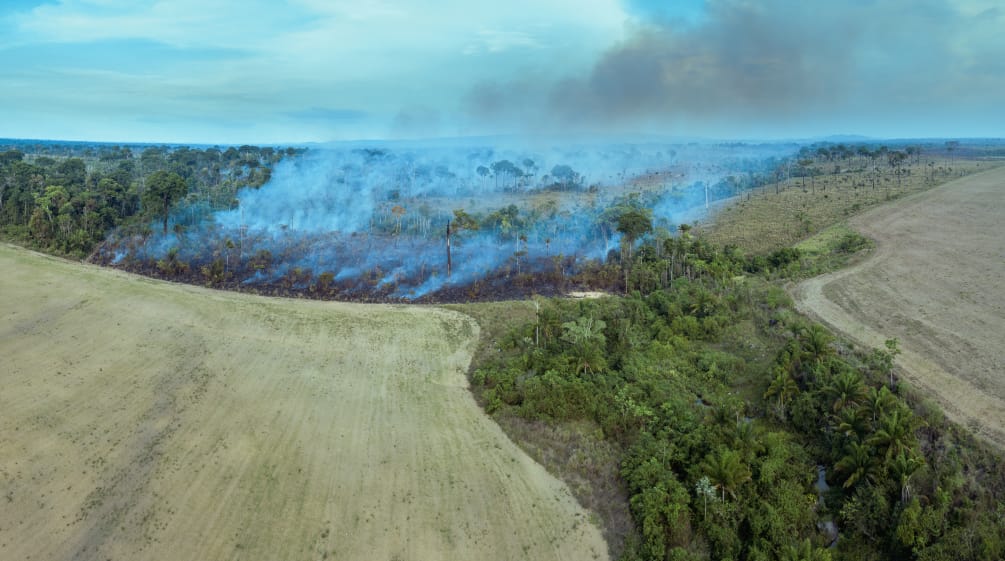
[0,137,1005,561]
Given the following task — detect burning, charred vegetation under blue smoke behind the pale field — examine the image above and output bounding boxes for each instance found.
[92,139,794,302]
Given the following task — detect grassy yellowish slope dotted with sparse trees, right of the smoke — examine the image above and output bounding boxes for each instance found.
[699,160,1001,253]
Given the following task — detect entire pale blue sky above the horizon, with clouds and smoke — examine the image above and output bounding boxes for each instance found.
[0,0,1005,144]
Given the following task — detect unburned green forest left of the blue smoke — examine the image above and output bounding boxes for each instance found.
[0,143,296,257]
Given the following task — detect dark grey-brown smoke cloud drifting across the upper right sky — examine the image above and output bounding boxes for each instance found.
[465,0,1005,138]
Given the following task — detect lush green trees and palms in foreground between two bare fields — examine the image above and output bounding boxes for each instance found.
[471,232,1005,561]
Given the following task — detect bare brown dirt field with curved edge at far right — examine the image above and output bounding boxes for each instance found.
[794,168,1005,448]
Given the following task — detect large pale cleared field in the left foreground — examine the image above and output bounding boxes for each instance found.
[0,245,607,560]
